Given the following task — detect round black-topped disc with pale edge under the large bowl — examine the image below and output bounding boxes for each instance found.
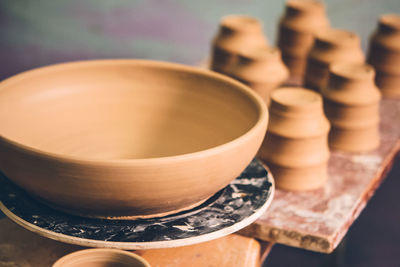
[0,159,275,250]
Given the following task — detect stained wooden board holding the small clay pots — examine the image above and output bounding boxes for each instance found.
[241,99,400,253]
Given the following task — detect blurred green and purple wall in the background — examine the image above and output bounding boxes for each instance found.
[0,0,400,80]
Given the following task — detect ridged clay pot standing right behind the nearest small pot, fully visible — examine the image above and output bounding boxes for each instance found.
[321,63,381,152]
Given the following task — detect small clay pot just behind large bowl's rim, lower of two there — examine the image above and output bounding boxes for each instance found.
[225,47,289,104]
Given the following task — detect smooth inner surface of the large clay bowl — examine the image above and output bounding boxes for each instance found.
[0,60,260,159]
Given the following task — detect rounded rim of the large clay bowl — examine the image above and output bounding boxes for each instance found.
[0,59,269,165]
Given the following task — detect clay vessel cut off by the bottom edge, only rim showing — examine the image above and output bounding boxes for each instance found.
[53,248,150,267]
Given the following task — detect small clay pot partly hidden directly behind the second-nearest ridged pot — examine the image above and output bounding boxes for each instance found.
[305,29,364,91]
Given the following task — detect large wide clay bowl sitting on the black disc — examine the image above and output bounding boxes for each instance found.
[0,60,268,218]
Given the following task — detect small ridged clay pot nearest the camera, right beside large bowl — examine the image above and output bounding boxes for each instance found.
[259,87,329,190]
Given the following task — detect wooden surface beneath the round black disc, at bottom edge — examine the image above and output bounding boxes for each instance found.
[0,218,272,267]
